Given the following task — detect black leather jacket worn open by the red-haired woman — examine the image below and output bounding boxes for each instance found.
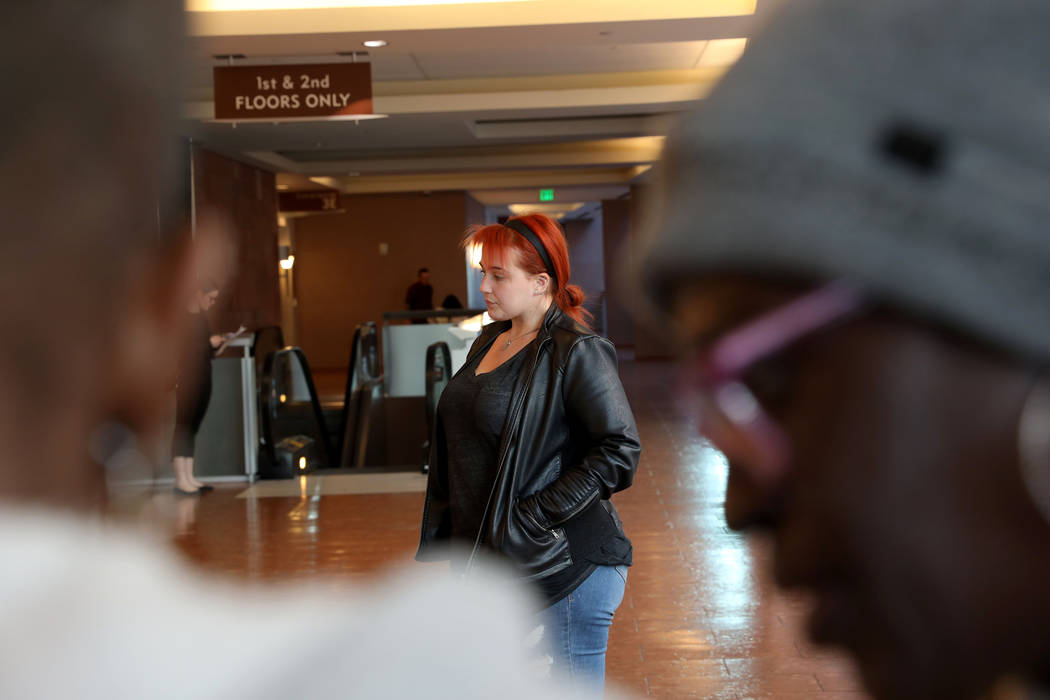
[416,304,642,579]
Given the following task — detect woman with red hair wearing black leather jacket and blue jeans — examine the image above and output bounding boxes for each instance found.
[416,214,641,695]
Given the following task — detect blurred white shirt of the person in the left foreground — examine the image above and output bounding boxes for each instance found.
[0,509,613,700]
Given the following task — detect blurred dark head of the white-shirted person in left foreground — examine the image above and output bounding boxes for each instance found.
[0,0,226,507]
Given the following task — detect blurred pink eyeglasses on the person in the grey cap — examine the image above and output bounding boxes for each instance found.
[690,281,864,486]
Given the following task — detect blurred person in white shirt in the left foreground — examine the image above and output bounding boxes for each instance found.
[0,0,613,700]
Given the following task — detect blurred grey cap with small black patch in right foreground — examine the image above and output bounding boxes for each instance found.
[633,0,1050,359]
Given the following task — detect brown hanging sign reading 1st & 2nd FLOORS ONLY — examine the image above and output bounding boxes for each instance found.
[213,63,372,122]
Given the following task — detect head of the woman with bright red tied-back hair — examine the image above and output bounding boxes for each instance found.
[463,214,587,323]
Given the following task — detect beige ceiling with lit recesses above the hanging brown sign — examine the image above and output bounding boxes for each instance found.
[178,0,774,205]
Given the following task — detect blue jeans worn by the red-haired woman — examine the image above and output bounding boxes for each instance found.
[537,566,627,698]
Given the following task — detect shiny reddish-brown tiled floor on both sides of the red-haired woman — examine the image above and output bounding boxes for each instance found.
[168,362,867,700]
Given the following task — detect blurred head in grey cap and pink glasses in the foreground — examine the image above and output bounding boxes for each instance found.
[637,0,1050,700]
